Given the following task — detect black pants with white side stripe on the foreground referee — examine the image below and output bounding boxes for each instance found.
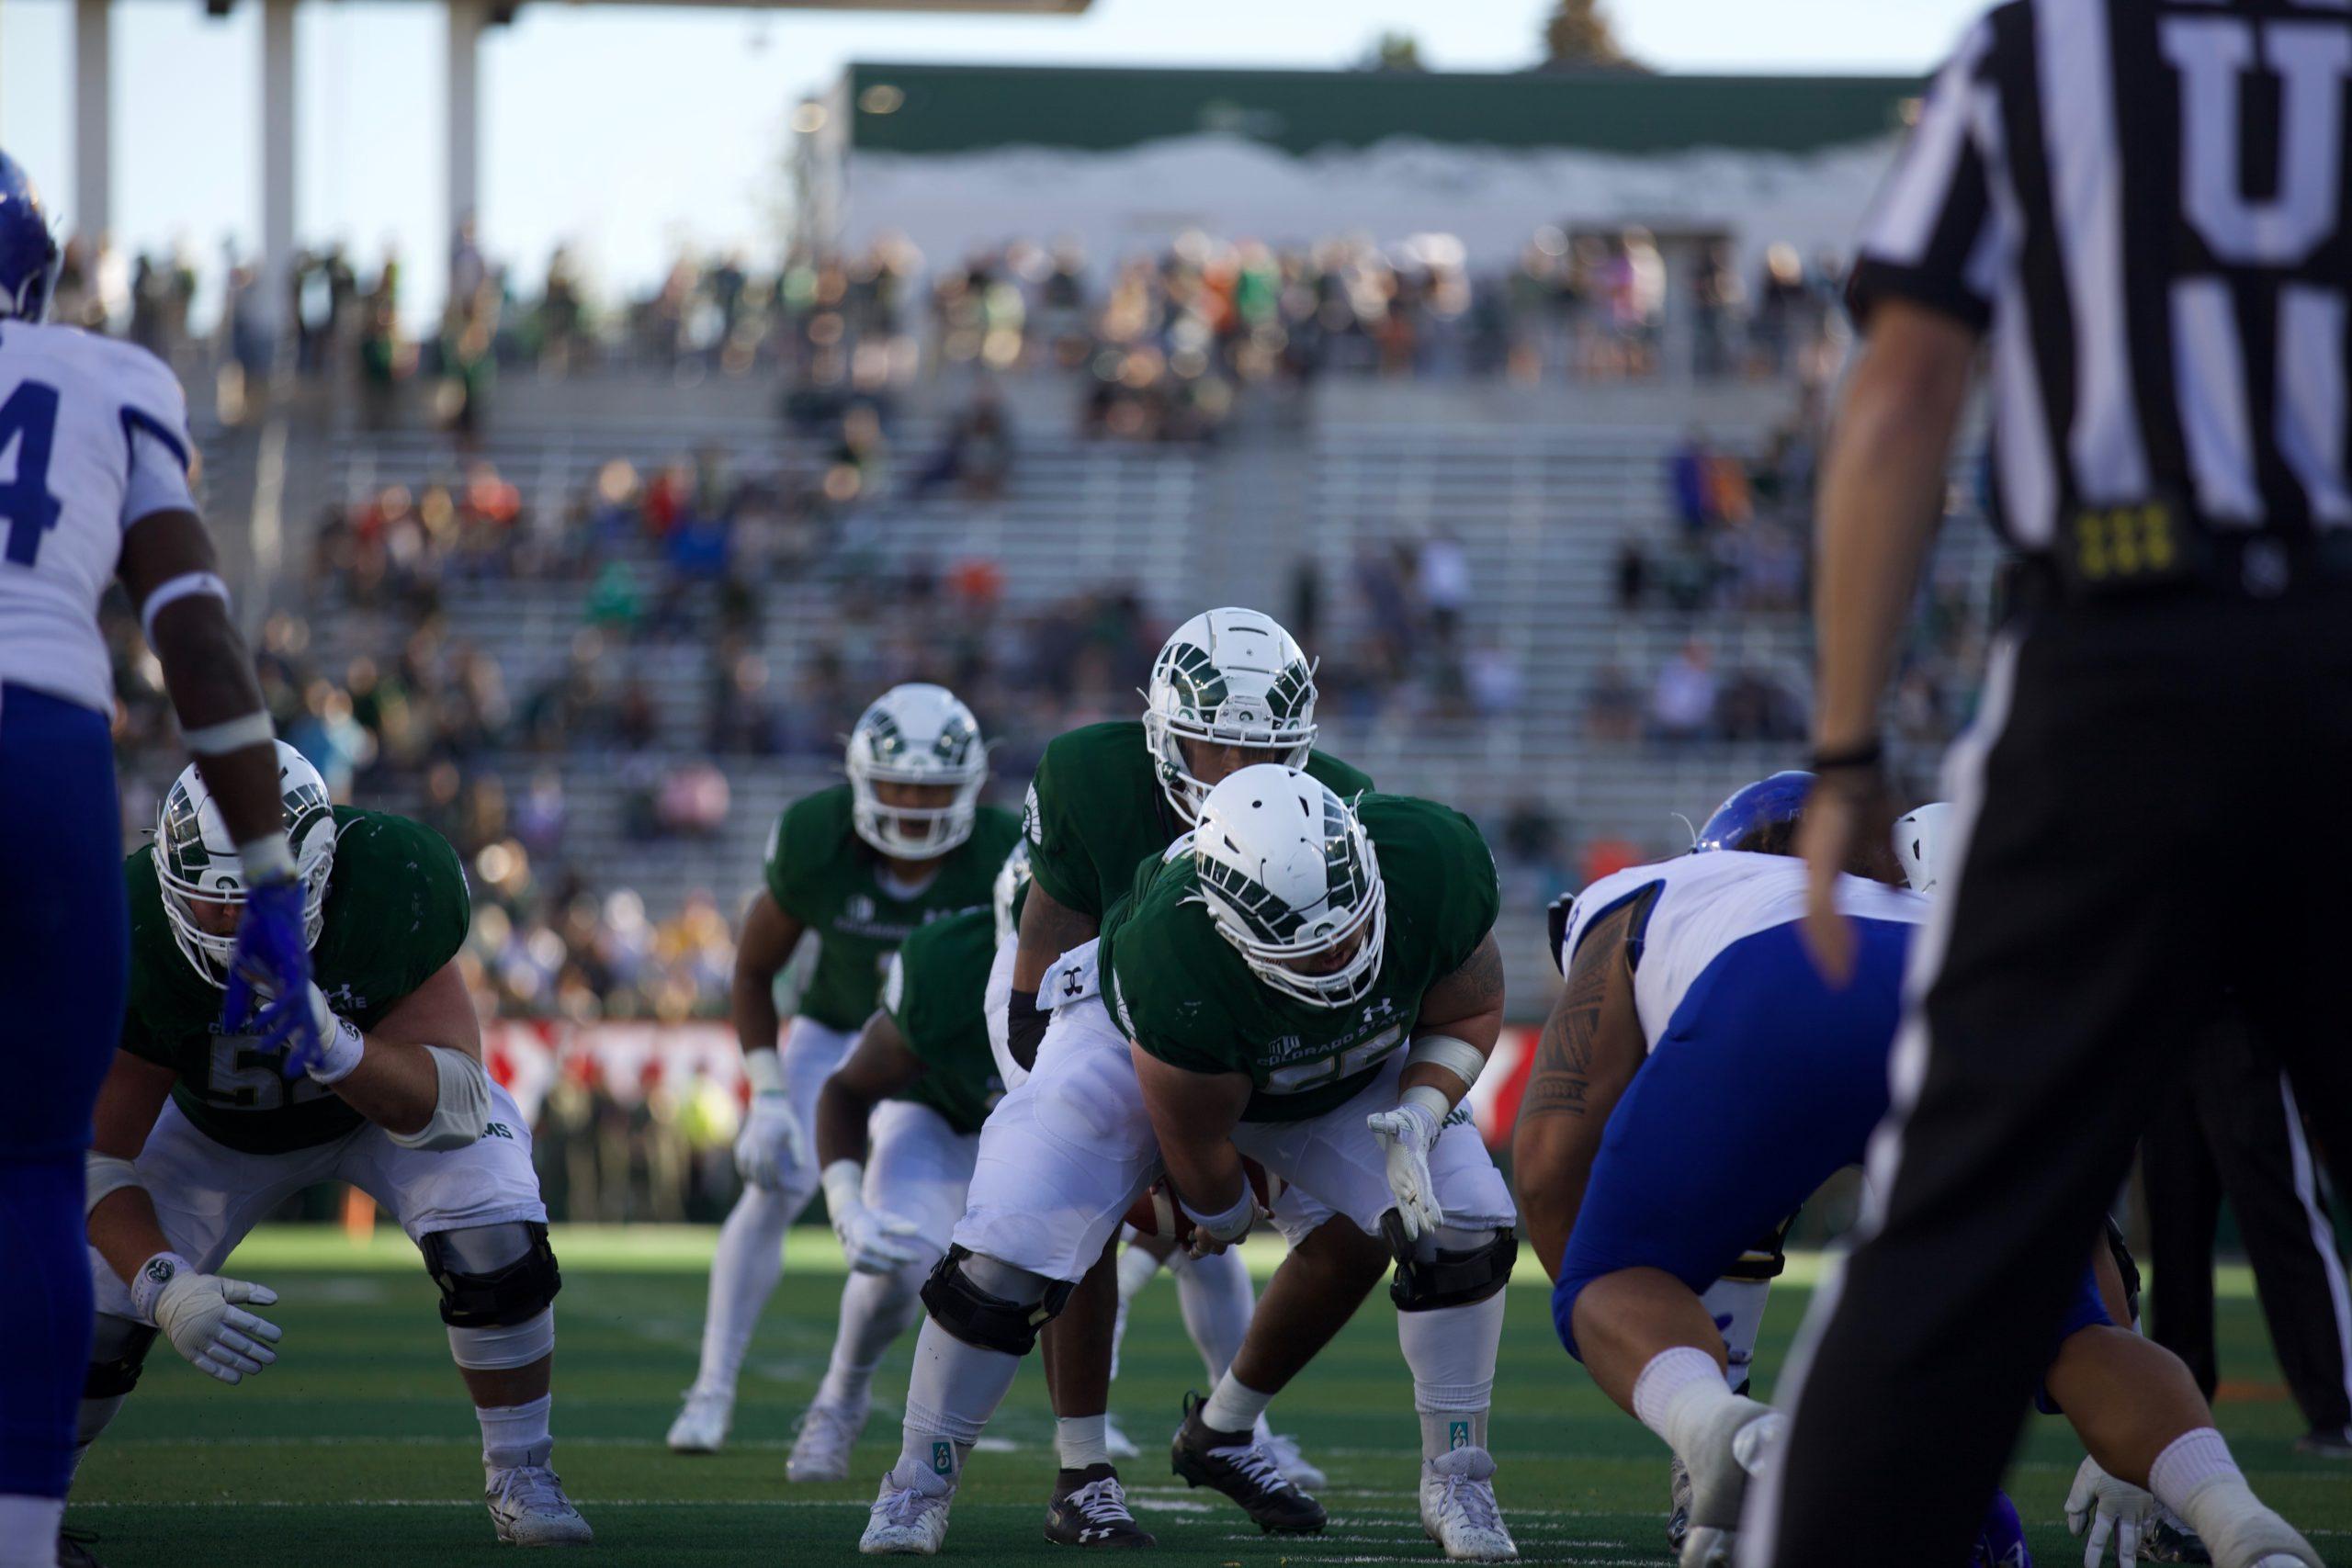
[1740,585,2352,1568]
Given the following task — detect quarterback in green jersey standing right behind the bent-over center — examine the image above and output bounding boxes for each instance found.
[990,606,1387,1542]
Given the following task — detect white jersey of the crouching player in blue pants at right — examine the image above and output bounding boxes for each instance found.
[1559,849,1928,1048]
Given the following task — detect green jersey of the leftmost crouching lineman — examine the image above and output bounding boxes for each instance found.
[122,807,473,1155]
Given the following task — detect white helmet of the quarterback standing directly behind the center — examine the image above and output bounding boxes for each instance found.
[1143,606,1315,823]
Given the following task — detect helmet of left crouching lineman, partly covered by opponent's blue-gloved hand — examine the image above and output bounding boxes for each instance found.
[148,740,334,985]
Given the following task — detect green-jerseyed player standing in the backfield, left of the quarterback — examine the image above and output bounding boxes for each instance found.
[671,684,1021,1481]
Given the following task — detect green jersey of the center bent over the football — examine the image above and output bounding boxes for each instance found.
[1099,795,1503,1122]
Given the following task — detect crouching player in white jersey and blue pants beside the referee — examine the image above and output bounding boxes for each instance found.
[1515,773,2319,1568]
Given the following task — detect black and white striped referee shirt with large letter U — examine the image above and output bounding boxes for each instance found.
[1851,0,2352,550]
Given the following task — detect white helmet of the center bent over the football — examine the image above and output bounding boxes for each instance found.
[1193,761,1387,1006]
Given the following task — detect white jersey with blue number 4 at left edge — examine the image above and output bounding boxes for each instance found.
[0,320,193,712]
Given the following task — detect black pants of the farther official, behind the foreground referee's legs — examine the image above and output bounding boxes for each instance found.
[2141,1018,2352,1434]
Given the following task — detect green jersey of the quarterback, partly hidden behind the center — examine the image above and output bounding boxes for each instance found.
[1023,719,1371,921]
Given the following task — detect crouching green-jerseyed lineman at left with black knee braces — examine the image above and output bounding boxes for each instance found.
[80,743,591,1547]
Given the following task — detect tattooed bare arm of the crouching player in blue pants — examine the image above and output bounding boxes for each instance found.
[1510,894,1654,1279]
